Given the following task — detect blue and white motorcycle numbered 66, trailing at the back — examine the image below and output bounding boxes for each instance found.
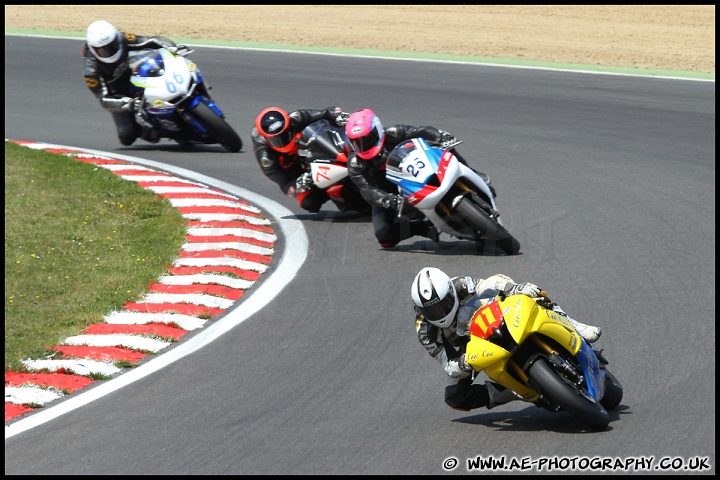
[128,48,242,152]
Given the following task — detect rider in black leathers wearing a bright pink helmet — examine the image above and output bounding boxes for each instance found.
[345,109,486,248]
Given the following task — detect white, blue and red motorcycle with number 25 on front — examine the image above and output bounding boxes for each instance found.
[385,138,520,255]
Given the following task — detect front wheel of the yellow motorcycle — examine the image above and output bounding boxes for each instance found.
[528,358,610,431]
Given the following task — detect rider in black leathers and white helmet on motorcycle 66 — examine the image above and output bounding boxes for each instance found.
[82,20,187,145]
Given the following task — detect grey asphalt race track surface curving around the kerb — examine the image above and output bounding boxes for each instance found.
[5,35,715,475]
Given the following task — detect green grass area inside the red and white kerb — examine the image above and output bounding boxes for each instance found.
[5,142,186,371]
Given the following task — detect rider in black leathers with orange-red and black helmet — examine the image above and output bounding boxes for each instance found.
[250,106,366,213]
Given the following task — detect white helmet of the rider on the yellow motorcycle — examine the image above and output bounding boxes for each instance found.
[410,267,459,328]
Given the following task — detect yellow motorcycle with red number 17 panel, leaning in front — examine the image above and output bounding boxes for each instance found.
[458,292,623,430]
